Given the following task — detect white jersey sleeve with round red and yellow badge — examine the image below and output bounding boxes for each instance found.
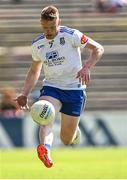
[73,30,89,48]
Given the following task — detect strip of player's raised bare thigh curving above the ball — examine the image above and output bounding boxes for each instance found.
[39,96,62,113]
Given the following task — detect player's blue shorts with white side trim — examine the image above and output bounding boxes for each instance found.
[40,86,86,116]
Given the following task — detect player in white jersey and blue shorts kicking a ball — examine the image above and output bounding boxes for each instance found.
[17,6,104,167]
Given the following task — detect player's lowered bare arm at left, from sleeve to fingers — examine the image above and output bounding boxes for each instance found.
[16,60,42,109]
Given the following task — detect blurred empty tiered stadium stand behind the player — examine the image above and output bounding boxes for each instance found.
[0,0,127,110]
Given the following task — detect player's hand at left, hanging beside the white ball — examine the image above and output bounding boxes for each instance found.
[15,94,29,110]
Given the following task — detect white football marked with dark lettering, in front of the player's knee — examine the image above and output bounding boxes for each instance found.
[30,100,55,125]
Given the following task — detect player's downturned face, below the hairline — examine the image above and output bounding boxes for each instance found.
[41,19,60,39]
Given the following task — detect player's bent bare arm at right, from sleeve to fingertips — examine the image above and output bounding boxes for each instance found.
[77,38,104,84]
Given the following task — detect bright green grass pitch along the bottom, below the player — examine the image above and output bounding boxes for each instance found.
[0,147,127,179]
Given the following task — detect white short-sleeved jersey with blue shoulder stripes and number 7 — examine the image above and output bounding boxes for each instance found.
[32,26,88,90]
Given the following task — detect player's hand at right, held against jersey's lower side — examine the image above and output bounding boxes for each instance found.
[76,66,90,85]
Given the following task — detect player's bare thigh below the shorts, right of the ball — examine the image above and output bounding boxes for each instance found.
[60,113,80,140]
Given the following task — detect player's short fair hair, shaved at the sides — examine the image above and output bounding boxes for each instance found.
[41,6,59,21]
